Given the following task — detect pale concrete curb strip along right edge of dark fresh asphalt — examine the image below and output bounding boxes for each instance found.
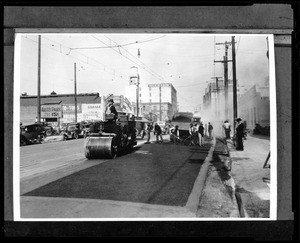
[185,138,216,214]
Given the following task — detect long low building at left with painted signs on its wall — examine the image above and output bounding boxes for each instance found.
[20,92,105,127]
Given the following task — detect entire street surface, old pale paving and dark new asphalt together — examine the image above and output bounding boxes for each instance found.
[21,135,216,218]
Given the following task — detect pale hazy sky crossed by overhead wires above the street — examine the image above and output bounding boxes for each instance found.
[20,33,268,111]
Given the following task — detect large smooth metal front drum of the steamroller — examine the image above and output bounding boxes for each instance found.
[84,137,117,159]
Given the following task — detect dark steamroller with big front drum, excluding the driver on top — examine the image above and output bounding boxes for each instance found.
[84,114,137,159]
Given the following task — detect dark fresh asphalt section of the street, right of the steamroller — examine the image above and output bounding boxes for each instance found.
[21,136,211,217]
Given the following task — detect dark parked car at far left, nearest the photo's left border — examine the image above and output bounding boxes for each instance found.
[20,123,46,146]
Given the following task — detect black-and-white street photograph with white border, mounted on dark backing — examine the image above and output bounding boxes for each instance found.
[13,32,277,221]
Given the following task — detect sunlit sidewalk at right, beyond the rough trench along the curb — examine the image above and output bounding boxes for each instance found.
[227,135,270,218]
